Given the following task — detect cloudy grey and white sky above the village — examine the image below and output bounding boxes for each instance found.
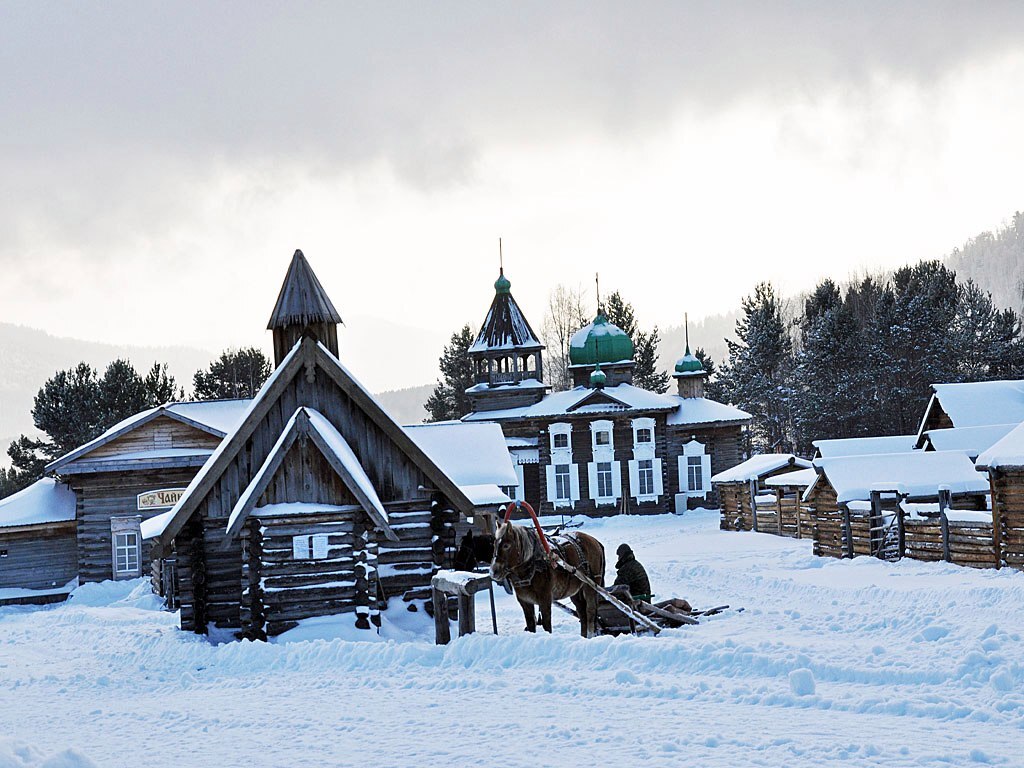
[0,0,1024,388]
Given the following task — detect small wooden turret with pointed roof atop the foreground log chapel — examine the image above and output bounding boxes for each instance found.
[267,251,342,367]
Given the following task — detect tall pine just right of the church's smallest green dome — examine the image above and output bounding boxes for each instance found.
[720,283,793,453]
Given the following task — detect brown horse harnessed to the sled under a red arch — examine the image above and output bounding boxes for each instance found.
[490,523,604,637]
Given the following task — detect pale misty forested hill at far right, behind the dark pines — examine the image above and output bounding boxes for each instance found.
[946,211,1024,314]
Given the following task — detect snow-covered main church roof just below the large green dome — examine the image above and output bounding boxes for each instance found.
[464,384,679,421]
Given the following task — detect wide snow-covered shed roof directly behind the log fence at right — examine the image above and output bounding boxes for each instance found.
[804,451,988,504]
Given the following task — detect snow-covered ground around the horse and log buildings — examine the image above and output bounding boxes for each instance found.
[0,513,1024,768]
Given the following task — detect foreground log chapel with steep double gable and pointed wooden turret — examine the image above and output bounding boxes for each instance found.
[146,251,494,638]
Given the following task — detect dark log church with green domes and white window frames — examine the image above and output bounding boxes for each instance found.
[463,269,752,516]
